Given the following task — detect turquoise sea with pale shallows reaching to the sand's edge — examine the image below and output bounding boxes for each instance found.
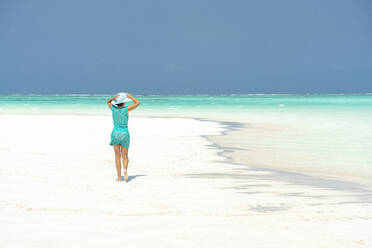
[0,94,372,185]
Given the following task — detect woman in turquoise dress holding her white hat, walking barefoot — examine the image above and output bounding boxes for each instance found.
[107,93,140,182]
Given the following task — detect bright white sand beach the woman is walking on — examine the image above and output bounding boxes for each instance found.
[0,115,372,248]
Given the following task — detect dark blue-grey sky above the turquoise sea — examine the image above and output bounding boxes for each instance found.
[0,0,372,94]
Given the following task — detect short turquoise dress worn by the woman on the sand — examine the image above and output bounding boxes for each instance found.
[110,105,130,148]
